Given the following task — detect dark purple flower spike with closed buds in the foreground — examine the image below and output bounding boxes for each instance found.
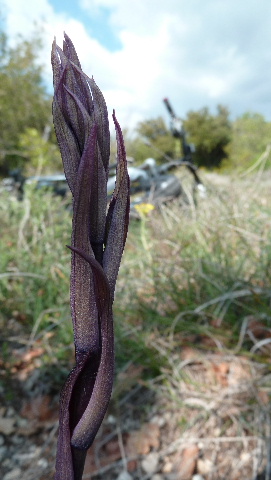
[52,35,129,480]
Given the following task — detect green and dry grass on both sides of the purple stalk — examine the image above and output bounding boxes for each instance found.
[0,169,271,373]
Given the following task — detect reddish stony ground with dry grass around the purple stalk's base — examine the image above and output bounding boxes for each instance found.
[0,330,270,480]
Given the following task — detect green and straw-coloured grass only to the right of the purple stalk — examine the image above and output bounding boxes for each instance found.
[116,171,271,370]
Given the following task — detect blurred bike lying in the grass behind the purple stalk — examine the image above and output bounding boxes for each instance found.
[0,98,206,218]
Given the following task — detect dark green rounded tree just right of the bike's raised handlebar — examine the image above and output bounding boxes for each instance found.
[184,105,232,168]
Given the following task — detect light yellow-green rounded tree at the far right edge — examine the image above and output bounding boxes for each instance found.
[227,112,271,170]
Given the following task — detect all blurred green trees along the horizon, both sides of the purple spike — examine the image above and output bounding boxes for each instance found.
[0,26,271,177]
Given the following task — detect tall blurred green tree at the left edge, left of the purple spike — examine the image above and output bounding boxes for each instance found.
[0,33,52,175]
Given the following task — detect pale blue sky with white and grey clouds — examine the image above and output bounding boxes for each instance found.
[0,0,271,131]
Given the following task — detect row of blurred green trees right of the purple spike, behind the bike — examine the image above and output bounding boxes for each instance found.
[126,105,271,172]
